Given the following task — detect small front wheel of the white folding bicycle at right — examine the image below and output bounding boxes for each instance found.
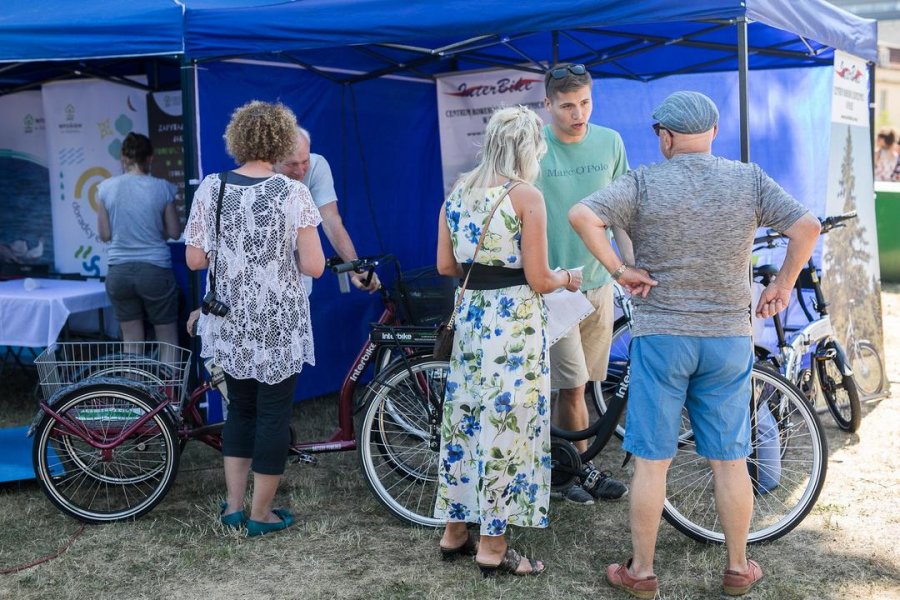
[812,340,862,433]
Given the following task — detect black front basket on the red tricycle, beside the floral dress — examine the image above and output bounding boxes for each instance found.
[393,267,456,326]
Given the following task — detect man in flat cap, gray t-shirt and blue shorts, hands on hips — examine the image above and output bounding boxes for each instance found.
[569,92,819,595]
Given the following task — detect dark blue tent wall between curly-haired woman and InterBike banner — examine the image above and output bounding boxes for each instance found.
[197,62,443,397]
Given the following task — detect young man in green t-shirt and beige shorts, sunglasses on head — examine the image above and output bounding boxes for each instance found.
[537,63,634,504]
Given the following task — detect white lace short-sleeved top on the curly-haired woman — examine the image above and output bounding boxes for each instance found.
[184,174,322,383]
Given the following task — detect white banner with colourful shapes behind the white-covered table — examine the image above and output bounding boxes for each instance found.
[42,79,147,275]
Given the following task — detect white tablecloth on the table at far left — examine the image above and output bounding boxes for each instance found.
[0,279,110,348]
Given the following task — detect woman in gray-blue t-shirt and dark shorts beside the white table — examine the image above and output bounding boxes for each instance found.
[97,132,181,362]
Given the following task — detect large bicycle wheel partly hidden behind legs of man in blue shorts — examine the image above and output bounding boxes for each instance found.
[663,366,828,543]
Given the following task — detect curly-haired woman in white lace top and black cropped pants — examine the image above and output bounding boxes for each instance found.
[185,101,325,536]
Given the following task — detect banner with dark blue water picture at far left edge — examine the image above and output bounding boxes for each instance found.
[0,91,53,272]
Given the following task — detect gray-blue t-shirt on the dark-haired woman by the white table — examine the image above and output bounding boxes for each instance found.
[97,174,177,268]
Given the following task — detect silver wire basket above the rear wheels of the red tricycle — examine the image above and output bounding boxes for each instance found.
[34,342,191,404]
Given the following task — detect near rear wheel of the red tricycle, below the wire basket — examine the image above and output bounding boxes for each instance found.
[32,383,179,523]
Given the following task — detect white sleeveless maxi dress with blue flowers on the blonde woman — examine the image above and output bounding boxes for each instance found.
[435,186,550,535]
